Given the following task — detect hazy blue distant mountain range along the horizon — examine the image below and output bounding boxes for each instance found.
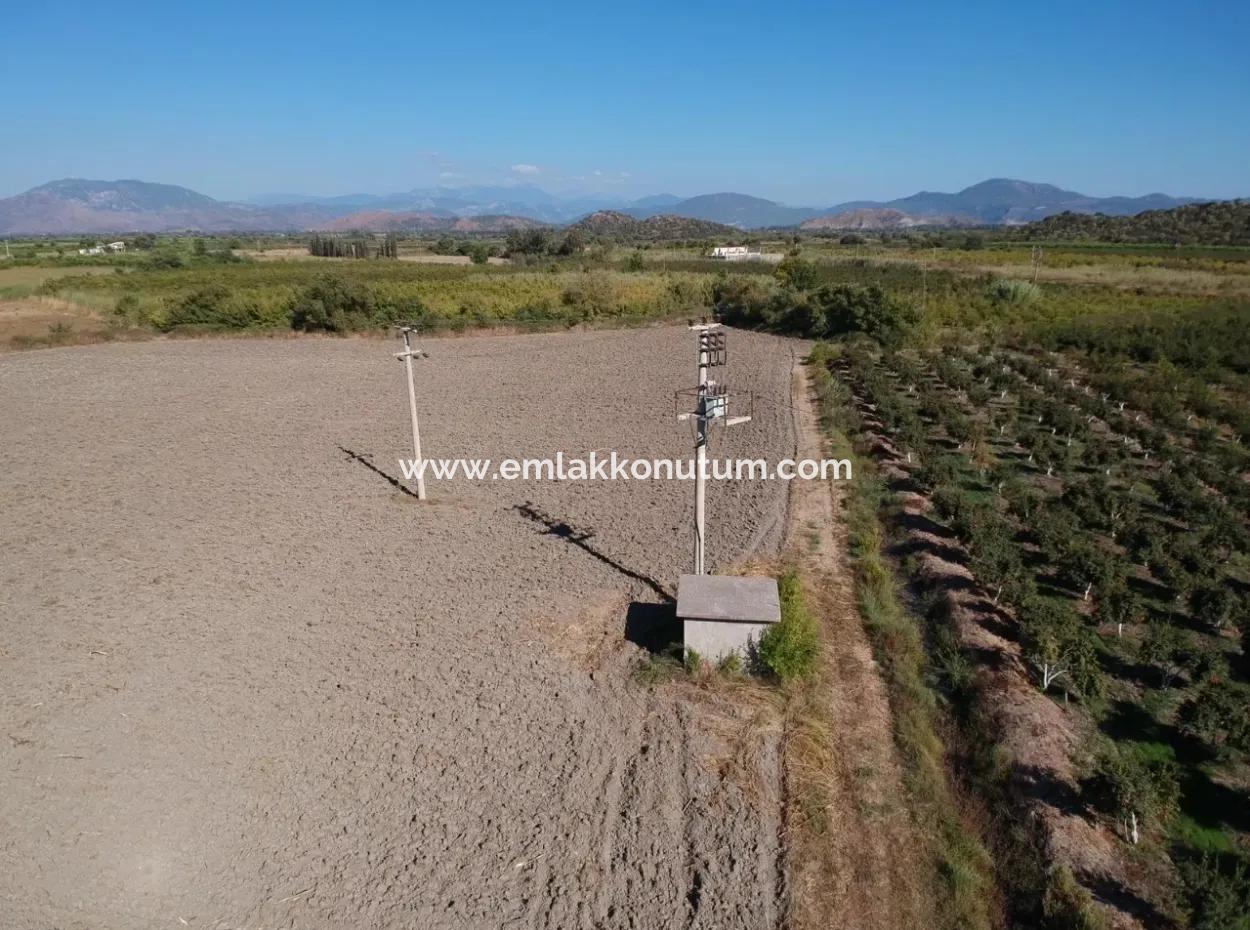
[0,178,1215,235]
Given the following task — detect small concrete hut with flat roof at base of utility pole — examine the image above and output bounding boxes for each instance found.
[678,575,781,663]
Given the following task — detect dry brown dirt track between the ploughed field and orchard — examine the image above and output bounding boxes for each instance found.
[786,362,931,930]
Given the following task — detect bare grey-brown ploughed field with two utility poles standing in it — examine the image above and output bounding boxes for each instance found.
[0,329,794,930]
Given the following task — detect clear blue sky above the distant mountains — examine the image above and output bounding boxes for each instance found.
[0,0,1250,205]
